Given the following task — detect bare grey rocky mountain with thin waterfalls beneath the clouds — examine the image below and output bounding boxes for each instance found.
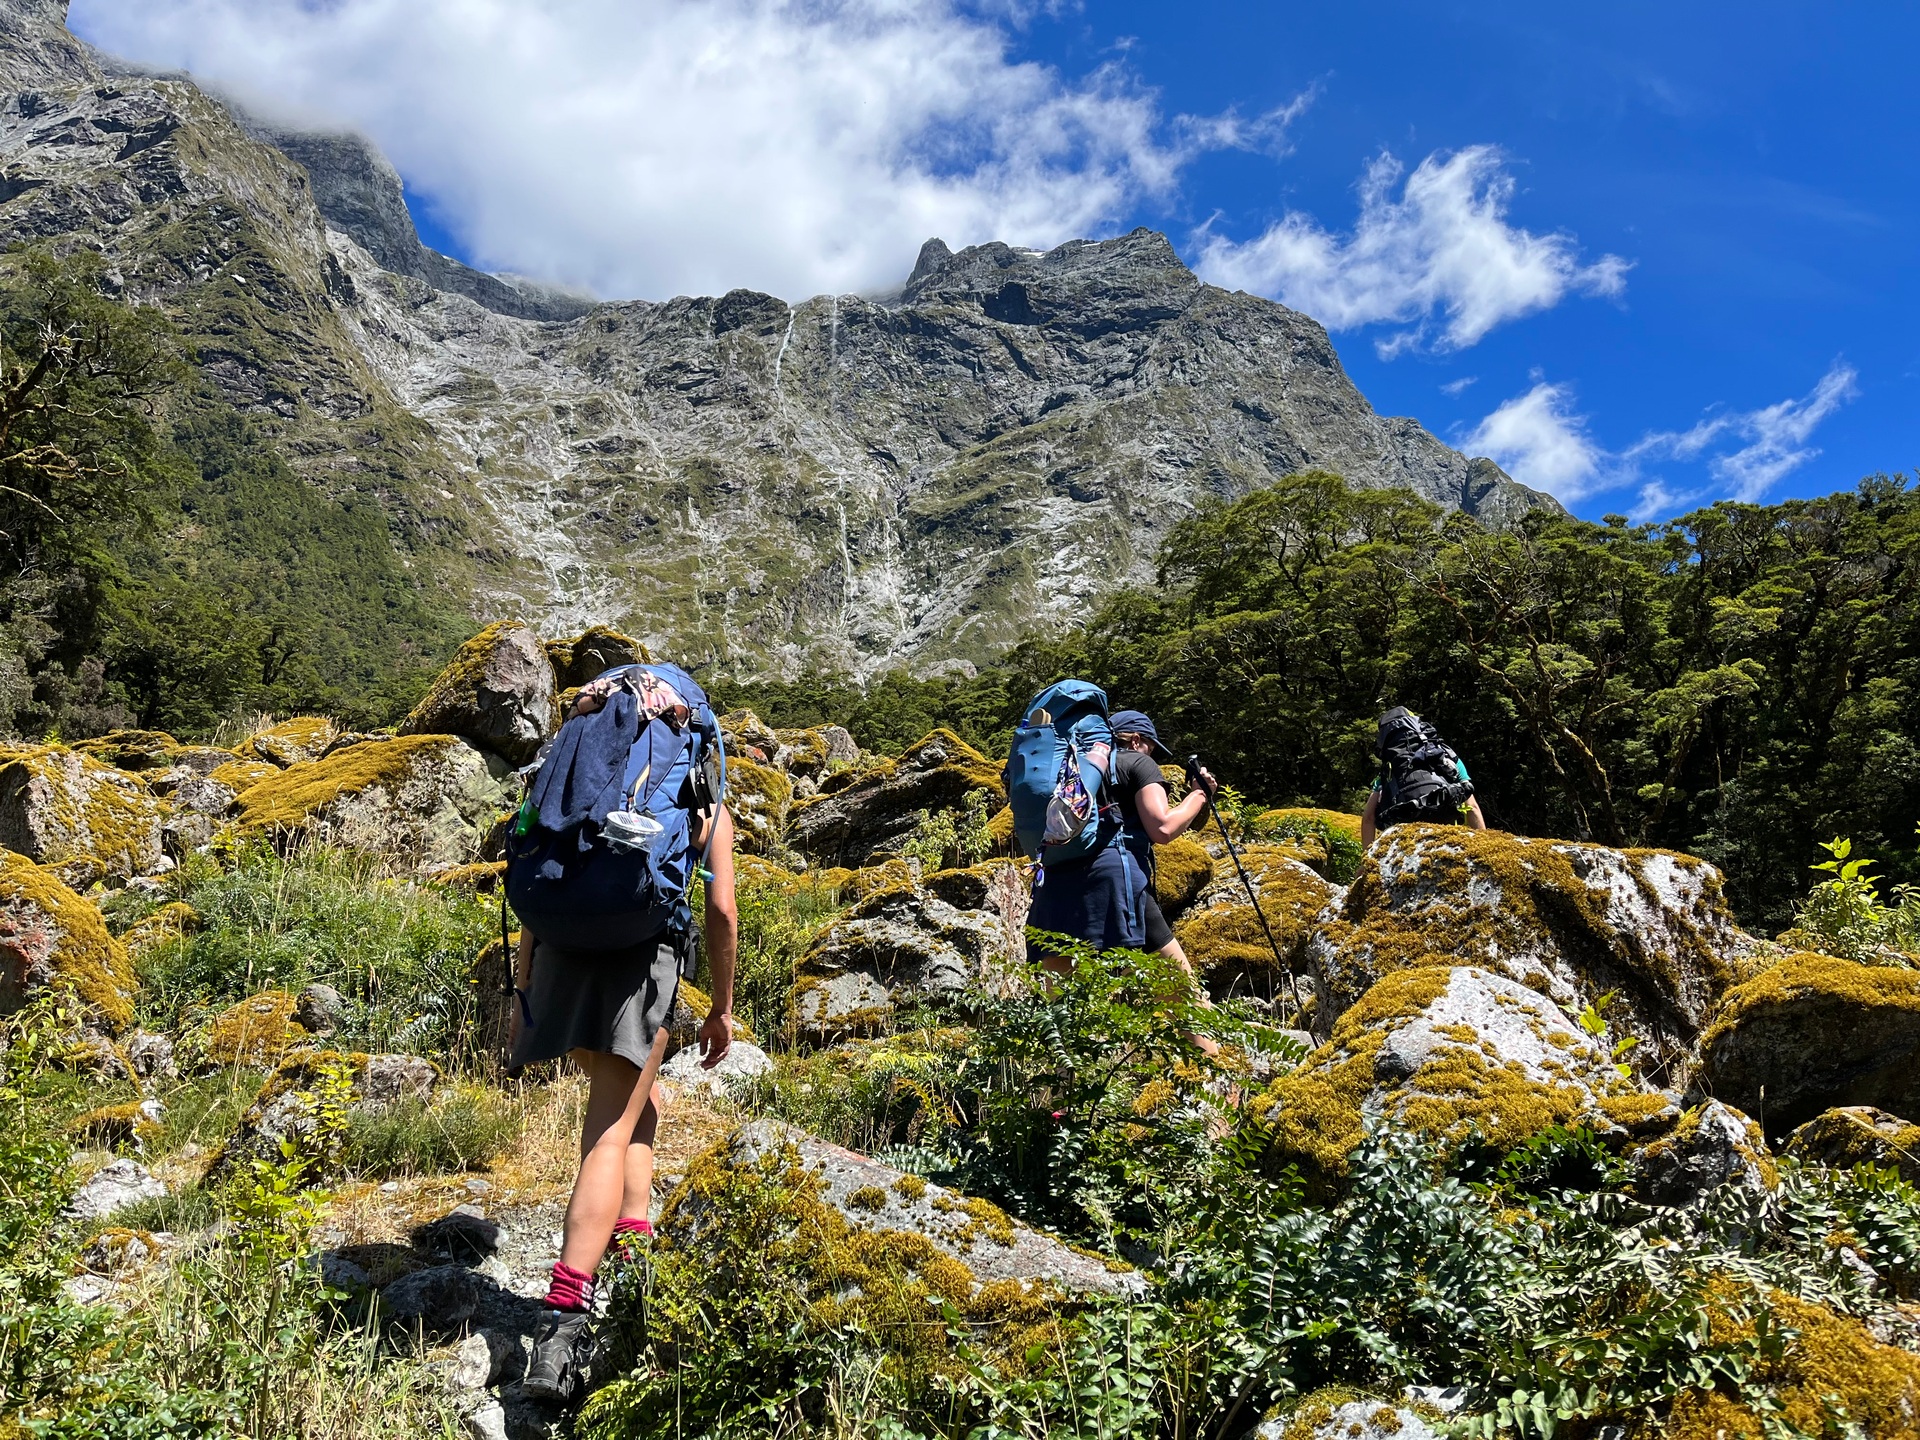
[0,0,1553,674]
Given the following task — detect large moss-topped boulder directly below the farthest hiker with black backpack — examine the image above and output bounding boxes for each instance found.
[1308,826,1759,1081]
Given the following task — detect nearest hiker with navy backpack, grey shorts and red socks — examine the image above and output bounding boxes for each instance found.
[507,662,737,1400]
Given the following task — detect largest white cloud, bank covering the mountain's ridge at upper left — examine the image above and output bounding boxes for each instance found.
[71,0,1290,300]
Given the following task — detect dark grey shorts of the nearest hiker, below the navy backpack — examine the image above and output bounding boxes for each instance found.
[509,935,680,1069]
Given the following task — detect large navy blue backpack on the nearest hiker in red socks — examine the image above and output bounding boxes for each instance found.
[507,662,726,950]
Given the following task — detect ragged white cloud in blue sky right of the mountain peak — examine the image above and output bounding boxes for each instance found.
[1198,146,1628,357]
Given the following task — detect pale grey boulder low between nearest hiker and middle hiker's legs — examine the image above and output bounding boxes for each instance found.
[787,866,1021,1043]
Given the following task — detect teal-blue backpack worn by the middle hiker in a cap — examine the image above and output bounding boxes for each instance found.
[1006,680,1119,866]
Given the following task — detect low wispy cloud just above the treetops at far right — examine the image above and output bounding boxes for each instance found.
[1459,361,1859,518]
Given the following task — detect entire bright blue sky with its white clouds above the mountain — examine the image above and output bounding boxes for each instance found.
[71,0,1920,518]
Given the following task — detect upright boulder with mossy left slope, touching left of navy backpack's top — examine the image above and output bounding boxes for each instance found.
[399,622,559,764]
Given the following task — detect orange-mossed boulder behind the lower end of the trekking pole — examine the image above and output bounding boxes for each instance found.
[1156,845,1340,998]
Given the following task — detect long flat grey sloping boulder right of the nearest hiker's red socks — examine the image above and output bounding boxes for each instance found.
[675,1119,1146,1298]
